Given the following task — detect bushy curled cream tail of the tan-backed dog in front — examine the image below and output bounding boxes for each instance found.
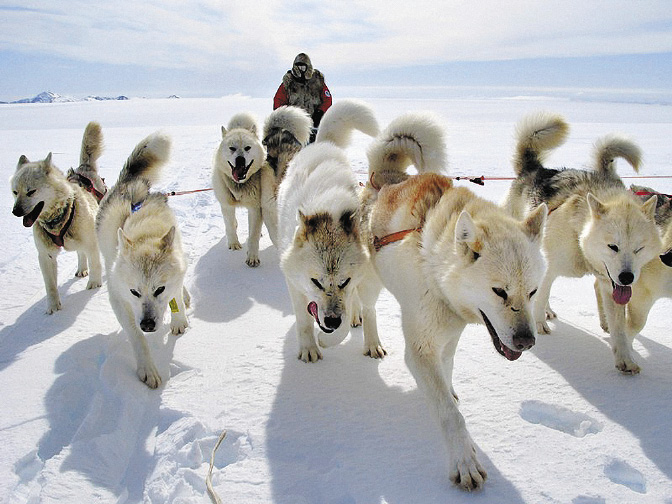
[367,113,447,185]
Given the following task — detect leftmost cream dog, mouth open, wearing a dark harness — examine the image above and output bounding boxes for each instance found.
[11,122,103,314]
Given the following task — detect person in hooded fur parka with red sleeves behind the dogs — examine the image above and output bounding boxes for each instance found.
[273,53,331,141]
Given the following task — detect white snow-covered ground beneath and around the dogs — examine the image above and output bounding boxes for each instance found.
[0,90,672,504]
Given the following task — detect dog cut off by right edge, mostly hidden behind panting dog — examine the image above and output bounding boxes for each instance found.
[595,185,672,373]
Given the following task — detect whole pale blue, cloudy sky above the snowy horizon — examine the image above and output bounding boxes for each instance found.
[0,0,672,100]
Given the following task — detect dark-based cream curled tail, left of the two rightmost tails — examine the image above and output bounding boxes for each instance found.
[513,112,569,175]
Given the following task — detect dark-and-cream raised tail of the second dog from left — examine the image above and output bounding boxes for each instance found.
[117,132,170,185]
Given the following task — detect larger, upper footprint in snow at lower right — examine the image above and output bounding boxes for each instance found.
[520,401,603,438]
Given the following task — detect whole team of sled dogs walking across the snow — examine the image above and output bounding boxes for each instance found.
[11,100,672,490]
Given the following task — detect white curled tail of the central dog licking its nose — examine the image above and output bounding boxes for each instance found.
[315,100,380,149]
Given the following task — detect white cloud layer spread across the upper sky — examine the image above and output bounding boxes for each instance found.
[0,0,672,73]
